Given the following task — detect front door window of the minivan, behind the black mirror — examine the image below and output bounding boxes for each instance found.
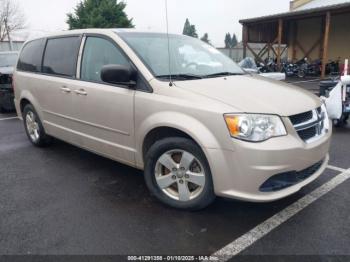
[80,37,130,83]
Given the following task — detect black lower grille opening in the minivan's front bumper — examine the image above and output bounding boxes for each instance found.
[260,160,324,192]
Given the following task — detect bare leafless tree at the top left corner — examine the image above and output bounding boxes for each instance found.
[0,0,25,42]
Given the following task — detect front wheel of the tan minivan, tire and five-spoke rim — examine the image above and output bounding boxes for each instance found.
[145,137,215,210]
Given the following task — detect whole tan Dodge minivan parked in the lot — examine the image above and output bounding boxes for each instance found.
[14,29,331,210]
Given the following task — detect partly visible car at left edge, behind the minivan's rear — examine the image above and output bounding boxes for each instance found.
[0,52,18,112]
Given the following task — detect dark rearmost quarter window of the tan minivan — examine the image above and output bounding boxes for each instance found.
[17,39,46,72]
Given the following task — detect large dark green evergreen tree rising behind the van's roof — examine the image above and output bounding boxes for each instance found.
[67,0,134,30]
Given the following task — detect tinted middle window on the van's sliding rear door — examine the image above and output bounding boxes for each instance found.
[43,36,80,77]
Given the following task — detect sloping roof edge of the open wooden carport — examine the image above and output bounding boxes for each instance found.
[239,0,350,24]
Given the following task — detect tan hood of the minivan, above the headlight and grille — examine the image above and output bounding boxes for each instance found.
[175,75,321,116]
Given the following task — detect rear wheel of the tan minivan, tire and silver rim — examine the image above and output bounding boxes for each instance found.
[22,104,53,147]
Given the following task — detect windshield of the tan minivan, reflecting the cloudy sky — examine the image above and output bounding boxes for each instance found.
[118,32,244,79]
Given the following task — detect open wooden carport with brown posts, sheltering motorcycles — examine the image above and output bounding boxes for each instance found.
[240,2,350,78]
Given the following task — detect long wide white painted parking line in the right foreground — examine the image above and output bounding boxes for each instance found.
[212,169,350,261]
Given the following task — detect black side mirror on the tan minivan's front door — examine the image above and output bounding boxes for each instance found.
[101,65,137,87]
